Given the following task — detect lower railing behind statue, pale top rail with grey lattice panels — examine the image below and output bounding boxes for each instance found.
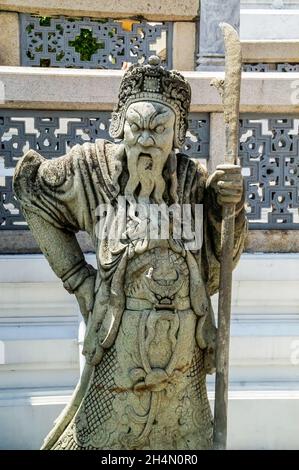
[0,67,299,251]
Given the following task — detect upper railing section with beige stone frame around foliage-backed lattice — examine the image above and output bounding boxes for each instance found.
[0,0,199,70]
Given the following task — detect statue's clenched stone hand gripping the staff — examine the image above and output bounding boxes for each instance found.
[207,164,243,206]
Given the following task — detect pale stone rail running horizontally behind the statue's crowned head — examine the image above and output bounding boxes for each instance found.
[0,66,299,114]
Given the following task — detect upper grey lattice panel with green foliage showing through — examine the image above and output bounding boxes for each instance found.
[20,14,172,69]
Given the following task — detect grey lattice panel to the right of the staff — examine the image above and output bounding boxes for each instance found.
[239,115,299,229]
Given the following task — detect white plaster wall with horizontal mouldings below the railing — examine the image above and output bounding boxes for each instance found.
[0,254,299,449]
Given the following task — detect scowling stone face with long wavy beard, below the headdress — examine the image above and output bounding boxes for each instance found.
[123,101,175,204]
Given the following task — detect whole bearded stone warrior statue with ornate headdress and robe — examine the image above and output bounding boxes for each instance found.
[14,57,246,450]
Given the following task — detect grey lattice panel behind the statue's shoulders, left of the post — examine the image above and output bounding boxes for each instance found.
[0,110,209,230]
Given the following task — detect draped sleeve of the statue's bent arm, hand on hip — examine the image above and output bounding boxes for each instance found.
[14,145,101,292]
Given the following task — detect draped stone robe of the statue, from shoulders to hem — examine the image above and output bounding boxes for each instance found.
[14,140,246,449]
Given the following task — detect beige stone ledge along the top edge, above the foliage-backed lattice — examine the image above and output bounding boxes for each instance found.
[0,0,199,21]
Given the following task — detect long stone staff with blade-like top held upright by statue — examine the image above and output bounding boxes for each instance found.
[212,23,242,449]
